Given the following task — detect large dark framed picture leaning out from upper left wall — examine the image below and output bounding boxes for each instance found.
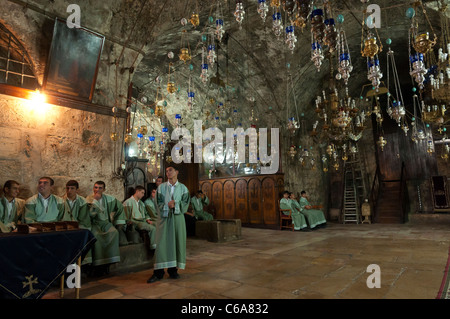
[43,18,105,101]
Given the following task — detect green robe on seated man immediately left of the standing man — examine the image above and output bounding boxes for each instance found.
[123,196,156,249]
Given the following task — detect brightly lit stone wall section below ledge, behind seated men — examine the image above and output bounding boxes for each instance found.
[0,95,124,200]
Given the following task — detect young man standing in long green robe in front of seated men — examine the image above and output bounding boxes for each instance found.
[147,166,190,283]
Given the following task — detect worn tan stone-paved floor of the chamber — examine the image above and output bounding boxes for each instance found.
[44,222,450,299]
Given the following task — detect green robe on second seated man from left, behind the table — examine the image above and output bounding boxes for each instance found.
[25,194,64,224]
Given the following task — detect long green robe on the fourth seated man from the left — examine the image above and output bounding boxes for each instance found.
[86,194,126,266]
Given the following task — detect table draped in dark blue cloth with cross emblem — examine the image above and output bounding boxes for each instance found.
[0,229,96,299]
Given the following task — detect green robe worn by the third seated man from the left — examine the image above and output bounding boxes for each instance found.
[63,195,92,265]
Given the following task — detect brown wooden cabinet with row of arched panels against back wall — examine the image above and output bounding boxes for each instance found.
[199,174,284,228]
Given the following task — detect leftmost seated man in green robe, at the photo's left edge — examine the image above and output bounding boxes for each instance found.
[0,180,25,233]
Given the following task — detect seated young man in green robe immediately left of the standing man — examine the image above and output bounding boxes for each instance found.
[123,185,156,249]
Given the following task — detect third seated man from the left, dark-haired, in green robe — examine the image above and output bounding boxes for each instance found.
[63,180,92,265]
